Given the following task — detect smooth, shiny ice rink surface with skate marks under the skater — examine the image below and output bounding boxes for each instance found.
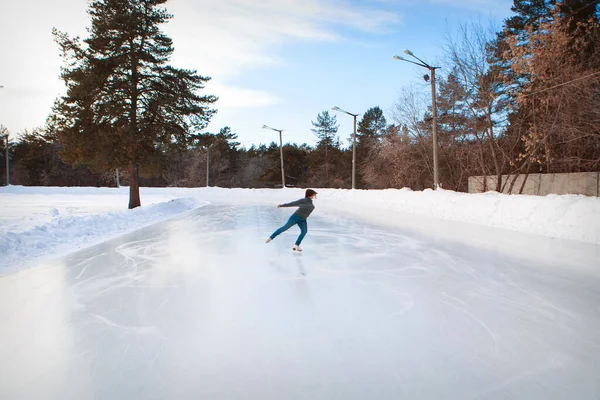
[0,205,600,399]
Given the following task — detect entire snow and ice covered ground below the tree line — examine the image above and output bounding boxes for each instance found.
[0,186,600,399]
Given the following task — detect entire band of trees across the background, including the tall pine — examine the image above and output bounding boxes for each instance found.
[0,0,600,200]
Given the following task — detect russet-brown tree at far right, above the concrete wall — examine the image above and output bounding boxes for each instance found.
[508,1,600,173]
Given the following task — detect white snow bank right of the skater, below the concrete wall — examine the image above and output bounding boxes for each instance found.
[324,189,600,243]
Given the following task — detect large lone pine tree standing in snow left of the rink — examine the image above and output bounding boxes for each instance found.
[48,0,217,208]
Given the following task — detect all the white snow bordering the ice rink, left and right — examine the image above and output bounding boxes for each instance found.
[0,186,600,274]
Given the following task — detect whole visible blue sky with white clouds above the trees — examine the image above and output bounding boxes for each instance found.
[0,0,512,146]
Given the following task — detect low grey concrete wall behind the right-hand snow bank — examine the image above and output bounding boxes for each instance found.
[469,172,600,196]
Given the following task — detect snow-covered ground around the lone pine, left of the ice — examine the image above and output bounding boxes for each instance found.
[0,187,202,275]
